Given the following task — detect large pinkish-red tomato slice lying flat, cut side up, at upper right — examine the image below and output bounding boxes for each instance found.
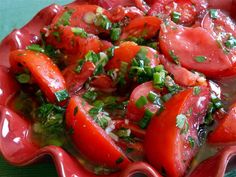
[160,22,233,78]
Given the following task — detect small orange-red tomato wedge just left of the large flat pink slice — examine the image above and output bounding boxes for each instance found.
[120,16,161,40]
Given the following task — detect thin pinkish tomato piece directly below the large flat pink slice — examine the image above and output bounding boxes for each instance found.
[159,56,206,86]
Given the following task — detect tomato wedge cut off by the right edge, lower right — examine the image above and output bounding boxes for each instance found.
[208,104,236,144]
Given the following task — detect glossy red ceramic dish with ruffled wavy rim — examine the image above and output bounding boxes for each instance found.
[0,0,236,177]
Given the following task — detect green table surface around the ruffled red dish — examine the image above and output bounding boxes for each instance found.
[0,0,236,177]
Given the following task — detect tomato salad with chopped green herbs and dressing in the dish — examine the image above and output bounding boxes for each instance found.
[6,0,236,177]
